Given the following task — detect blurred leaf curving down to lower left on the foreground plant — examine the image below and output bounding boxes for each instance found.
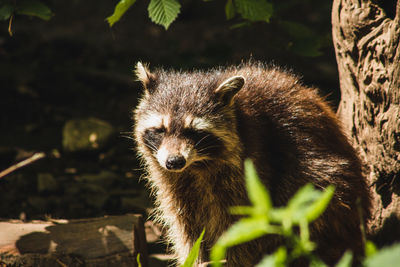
[211,218,268,266]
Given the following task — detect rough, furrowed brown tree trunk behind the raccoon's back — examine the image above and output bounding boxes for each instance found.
[332,0,400,243]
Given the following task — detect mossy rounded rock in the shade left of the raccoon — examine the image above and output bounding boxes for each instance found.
[62,118,115,152]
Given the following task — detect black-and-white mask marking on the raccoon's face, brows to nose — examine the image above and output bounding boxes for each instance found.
[138,113,224,172]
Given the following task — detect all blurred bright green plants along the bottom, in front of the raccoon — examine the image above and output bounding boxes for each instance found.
[183,160,400,267]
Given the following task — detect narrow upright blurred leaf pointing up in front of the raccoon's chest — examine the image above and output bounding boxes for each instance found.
[244,159,272,214]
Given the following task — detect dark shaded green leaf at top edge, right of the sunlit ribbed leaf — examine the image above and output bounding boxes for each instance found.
[235,0,273,22]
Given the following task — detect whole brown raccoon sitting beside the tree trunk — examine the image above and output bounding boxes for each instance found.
[134,62,371,266]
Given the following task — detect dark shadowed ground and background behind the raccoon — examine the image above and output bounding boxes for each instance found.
[0,0,339,227]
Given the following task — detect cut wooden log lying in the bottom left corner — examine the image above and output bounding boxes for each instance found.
[0,214,147,267]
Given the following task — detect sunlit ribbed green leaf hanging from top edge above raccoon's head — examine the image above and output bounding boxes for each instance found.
[148,0,181,30]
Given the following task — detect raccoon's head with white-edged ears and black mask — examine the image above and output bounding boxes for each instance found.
[135,62,244,172]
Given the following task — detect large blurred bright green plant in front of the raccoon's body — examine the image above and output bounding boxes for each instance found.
[211,160,334,266]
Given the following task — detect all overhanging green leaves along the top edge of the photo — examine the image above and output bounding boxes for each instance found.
[0,0,324,57]
